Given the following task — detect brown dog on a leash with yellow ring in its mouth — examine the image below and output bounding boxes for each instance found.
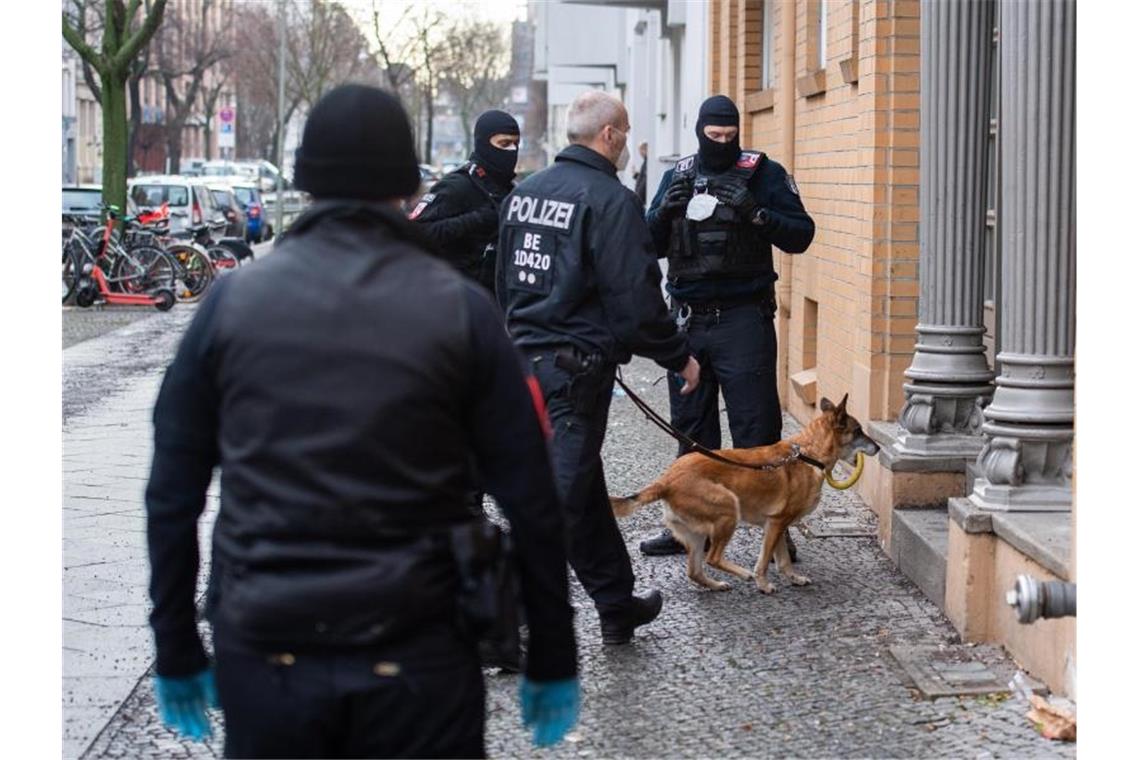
[610,395,879,594]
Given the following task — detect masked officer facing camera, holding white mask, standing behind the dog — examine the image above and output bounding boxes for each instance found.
[641,95,815,555]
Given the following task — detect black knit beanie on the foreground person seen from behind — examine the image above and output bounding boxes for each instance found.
[293,84,420,201]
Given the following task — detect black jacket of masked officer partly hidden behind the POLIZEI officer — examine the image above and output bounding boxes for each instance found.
[408,161,511,292]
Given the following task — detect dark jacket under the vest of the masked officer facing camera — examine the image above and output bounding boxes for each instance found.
[645,151,815,303]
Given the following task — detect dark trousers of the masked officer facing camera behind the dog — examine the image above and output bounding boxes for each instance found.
[669,302,783,456]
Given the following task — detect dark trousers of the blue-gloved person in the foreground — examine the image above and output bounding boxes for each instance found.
[214,626,486,758]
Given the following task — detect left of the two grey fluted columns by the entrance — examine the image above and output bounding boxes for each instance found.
[891,0,994,458]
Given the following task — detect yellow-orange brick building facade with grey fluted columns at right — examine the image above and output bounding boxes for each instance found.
[709,0,1076,696]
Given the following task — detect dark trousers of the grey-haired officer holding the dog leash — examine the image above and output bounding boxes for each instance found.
[527,349,634,618]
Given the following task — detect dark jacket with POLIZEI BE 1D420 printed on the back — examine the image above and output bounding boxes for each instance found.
[496,145,689,371]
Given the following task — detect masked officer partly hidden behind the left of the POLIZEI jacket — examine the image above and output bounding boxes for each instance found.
[408,111,519,293]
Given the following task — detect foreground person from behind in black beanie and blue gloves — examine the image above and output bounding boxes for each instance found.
[146,85,578,758]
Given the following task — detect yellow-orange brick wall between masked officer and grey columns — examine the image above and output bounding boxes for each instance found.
[710,0,919,428]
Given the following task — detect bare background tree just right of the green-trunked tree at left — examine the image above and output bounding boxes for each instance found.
[155,0,233,172]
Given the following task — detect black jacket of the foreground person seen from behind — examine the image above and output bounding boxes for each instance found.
[146,202,576,679]
